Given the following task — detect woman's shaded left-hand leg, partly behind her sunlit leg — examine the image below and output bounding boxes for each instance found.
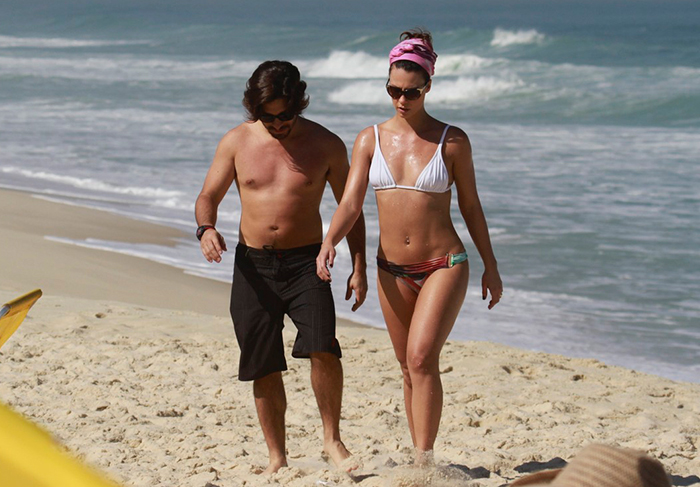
[377,270,418,446]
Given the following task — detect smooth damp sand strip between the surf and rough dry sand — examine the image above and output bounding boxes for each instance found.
[0,189,372,329]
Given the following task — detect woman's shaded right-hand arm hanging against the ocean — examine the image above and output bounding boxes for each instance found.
[452,128,503,309]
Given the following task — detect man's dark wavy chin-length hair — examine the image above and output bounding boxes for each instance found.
[243,61,309,121]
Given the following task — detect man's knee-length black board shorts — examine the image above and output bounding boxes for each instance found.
[231,243,342,381]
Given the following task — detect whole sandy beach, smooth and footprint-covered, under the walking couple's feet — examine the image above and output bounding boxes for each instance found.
[0,190,700,487]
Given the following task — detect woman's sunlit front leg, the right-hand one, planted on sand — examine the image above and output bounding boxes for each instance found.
[405,263,469,463]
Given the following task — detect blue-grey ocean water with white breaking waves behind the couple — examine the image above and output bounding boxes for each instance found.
[0,0,700,382]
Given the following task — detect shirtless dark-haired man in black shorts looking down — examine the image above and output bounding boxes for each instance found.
[195,61,367,473]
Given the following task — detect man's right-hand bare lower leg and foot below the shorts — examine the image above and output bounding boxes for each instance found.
[311,353,358,471]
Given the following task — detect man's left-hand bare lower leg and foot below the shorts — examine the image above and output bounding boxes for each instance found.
[253,372,287,475]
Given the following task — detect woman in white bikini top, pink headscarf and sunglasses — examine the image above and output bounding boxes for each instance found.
[316,31,503,464]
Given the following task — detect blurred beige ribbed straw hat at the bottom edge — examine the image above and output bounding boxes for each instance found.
[510,444,671,487]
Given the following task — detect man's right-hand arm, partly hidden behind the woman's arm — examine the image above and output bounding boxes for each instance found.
[328,135,367,311]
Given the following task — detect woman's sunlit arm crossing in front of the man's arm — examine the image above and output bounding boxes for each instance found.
[316,128,374,282]
